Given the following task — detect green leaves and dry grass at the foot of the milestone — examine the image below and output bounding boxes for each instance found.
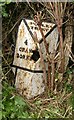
[0,67,74,120]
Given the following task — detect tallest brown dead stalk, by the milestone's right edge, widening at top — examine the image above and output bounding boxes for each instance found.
[53,3,64,73]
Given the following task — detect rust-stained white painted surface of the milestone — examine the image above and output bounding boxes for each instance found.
[13,20,58,99]
